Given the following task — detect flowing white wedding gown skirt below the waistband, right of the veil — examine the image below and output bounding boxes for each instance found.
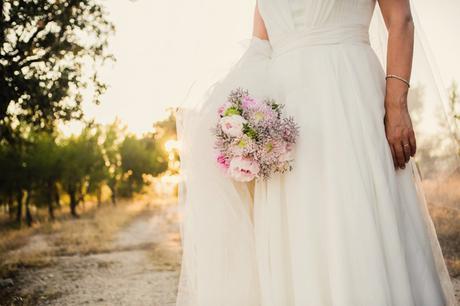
[254,44,454,306]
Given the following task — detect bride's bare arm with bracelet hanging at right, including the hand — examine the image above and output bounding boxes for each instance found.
[379,0,416,168]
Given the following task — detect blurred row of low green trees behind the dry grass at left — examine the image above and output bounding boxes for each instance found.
[0,120,171,223]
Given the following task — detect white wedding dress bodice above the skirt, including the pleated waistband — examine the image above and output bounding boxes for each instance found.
[259,0,375,54]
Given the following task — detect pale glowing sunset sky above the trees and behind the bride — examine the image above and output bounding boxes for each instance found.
[68,0,460,134]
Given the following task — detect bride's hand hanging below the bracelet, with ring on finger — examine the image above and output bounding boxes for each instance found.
[384,86,416,169]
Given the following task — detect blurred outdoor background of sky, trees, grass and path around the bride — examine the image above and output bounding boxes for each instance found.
[0,0,460,305]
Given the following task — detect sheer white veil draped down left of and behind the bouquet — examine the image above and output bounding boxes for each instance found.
[177,38,270,306]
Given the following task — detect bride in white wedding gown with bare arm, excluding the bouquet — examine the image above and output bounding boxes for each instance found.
[177,0,455,306]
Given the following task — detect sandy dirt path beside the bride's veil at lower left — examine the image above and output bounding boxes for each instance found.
[10,204,180,306]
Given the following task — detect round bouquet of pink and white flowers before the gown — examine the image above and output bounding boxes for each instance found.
[214,88,298,182]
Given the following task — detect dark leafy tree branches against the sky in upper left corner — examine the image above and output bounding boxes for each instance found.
[0,0,114,138]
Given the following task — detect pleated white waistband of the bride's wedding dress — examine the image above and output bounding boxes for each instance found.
[270,24,369,57]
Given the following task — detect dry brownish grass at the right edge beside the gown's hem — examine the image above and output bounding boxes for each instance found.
[423,173,460,277]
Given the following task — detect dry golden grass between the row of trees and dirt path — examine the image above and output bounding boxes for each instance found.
[0,199,150,278]
